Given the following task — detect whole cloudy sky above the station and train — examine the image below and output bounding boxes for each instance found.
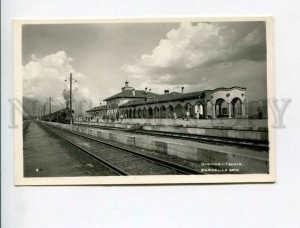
[22,22,266,105]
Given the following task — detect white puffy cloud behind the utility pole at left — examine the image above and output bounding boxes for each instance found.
[23,51,89,100]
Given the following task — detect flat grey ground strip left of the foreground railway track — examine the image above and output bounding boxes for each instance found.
[23,121,115,177]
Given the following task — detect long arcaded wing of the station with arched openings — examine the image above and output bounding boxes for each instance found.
[119,87,246,119]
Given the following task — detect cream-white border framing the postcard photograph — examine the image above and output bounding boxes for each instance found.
[13,16,275,185]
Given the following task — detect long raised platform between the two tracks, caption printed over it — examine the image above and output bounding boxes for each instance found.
[45,122,269,173]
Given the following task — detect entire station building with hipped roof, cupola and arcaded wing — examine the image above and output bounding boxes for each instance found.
[87,81,246,119]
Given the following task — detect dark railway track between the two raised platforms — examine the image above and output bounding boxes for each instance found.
[74,124,269,150]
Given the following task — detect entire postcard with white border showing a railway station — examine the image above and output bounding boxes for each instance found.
[13,17,275,185]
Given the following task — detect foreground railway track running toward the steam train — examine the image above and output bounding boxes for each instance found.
[42,124,203,176]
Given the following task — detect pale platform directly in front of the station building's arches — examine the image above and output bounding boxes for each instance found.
[75,119,269,142]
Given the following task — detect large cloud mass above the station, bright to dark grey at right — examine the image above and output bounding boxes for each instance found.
[122,22,266,99]
